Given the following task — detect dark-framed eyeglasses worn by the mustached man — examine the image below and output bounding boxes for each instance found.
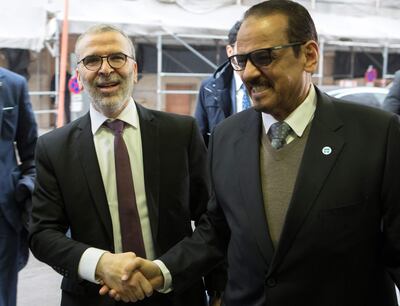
[229,42,305,71]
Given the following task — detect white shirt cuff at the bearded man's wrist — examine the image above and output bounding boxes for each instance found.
[78,248,108,284]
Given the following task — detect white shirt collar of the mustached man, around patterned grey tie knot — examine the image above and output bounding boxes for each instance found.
[262,85,317,137]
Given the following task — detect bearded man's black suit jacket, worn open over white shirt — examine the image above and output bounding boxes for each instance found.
[30,105,217,306]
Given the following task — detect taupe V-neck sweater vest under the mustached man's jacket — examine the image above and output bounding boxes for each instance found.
[260,124,310,247]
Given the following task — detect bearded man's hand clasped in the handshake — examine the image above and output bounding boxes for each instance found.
[96,252,153,302]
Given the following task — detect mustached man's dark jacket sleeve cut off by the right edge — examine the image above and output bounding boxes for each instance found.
[382,116,400,288]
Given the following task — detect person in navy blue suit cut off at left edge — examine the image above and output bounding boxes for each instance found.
[0,67,37,306]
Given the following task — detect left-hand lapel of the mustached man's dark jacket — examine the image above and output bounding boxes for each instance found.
[235,109,273,263]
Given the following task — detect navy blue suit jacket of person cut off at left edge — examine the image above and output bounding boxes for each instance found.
[0,67,37,268]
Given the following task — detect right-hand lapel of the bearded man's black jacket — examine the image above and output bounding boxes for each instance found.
[136,104,161,245]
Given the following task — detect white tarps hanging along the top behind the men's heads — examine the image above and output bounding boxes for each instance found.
[0,0,400,51]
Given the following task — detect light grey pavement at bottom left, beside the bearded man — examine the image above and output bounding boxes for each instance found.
[17,254,62,306]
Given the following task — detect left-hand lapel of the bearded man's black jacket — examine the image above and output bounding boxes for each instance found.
[76,114,114,241]
